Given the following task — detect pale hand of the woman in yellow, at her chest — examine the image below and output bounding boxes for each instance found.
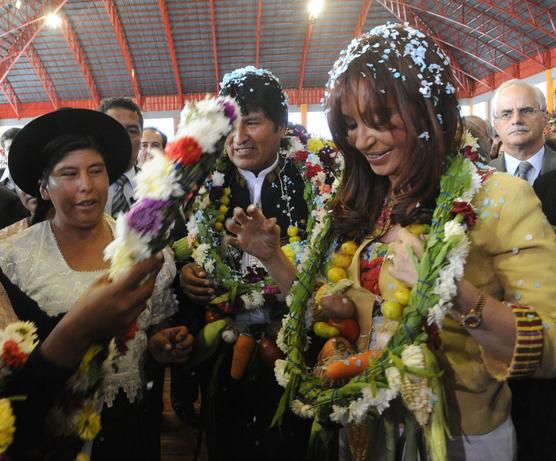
[387,228,424,287]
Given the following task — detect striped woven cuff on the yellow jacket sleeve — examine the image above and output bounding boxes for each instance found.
[509,304,544,378]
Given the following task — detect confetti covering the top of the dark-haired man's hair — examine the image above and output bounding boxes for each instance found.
[220,66,288,113]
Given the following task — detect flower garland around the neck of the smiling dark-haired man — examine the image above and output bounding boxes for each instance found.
[178,137,342,314]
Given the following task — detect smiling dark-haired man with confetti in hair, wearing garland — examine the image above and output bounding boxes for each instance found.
[180,66,310,461]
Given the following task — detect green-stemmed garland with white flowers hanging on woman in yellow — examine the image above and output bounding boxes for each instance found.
[274,137,489,460]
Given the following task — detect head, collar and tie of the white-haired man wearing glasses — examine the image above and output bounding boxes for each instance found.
[490,80,556,184]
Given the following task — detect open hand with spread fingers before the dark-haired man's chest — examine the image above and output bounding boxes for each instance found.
[226,205,280,264]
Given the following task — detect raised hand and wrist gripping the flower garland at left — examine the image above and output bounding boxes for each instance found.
[41,253,164,367]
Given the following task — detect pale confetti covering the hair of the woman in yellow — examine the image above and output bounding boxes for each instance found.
[324,23,456,113]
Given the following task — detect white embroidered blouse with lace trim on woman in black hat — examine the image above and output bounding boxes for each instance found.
[0,215,177,407]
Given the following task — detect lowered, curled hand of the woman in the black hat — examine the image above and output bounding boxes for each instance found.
[149,325,193,363]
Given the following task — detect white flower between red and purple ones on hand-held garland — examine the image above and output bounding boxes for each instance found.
[135,152,183,200]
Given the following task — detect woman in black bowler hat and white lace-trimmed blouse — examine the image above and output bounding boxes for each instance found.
[0,109,191,459]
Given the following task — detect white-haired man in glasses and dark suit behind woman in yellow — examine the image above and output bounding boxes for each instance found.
[490,80,556,461]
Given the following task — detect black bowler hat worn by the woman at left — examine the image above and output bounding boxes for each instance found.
[8,109,131,197]
